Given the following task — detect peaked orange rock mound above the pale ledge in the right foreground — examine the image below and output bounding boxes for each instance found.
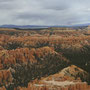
[44,65,89,81]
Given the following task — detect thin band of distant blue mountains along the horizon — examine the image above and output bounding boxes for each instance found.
[0,23,90,29]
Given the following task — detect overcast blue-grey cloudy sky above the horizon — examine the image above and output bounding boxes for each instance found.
[0,0,90,25]
